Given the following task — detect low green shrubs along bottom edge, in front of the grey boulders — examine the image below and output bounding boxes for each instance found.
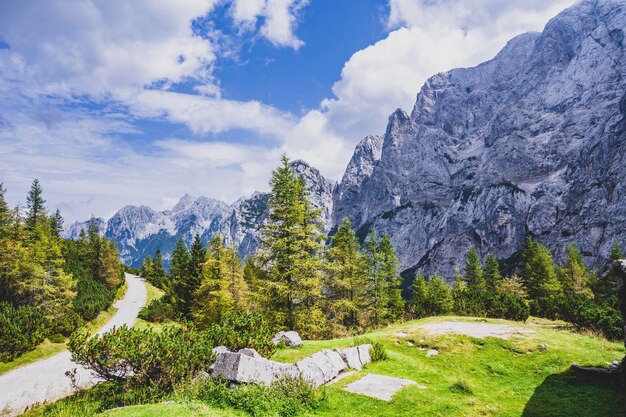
[178,378,327,417]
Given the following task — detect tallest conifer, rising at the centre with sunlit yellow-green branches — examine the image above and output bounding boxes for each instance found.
[259,156,325,337]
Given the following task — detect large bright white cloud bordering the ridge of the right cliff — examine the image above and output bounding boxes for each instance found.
[290,0,573,178]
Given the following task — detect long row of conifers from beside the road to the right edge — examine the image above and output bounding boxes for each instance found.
[142,157,622,338]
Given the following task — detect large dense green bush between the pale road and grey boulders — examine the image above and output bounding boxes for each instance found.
[69,326,214,391]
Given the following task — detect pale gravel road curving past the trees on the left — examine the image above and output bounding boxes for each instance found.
[0,274,147,416]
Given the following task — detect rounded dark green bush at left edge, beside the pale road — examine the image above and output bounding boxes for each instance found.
[0,302,47,362]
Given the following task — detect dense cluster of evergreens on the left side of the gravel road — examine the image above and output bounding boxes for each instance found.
[0,180,123,361]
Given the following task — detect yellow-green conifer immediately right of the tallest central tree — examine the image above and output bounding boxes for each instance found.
[324,218,367,334]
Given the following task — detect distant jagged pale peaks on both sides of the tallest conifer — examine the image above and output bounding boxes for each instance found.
[65,160,334,268]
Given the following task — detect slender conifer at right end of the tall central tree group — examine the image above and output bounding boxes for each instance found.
[378,233,404,321]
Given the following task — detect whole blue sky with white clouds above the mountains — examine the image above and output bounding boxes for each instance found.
[0,0,573,223]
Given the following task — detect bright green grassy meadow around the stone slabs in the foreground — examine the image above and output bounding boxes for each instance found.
[19,317,626,417]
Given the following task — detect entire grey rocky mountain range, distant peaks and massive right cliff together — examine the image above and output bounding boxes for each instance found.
[68,0,626,278]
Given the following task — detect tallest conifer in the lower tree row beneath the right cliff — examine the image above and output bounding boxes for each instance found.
[522,238,562,317]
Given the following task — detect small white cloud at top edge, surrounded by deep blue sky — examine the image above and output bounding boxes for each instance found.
[231,0,308,49]
